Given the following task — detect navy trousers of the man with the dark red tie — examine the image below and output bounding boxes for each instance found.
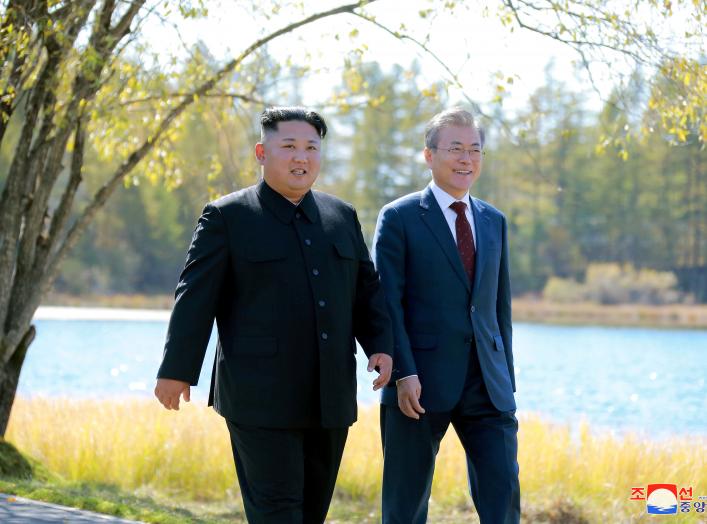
[381,345,520,524]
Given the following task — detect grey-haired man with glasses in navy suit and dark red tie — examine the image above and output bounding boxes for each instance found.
[374,108,520,524]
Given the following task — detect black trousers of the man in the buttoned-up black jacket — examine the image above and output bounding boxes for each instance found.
[226,420,348,524]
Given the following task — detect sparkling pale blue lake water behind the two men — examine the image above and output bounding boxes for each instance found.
[18,319,707,438]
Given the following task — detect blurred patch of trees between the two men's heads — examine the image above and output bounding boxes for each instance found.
[321,62,446,239]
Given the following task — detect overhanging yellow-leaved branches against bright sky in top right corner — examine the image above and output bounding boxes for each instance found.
[498,0,707,146]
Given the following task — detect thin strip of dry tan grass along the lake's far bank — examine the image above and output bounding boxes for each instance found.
[43,294,707,329]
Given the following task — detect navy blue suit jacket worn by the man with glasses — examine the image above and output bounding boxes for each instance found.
[373,186,515,412]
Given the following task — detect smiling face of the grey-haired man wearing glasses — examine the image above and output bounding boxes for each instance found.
[425,126,482,199]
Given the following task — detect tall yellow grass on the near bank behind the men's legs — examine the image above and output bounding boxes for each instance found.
[6,398,707,523]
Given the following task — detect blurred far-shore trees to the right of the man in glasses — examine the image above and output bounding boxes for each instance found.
[484,63,707,301]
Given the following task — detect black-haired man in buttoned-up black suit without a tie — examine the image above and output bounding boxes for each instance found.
[155,107,392,523]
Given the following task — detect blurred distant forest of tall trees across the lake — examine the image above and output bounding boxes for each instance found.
[0,63,707,302]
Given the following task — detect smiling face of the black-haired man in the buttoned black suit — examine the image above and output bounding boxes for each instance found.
[255,120,322,202]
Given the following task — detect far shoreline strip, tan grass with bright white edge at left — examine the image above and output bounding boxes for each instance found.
[33,295,707,329]
